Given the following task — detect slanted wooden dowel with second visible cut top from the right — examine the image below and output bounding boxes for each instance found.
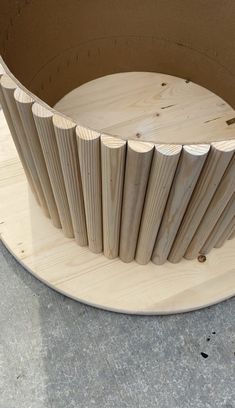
[152,145,210,265]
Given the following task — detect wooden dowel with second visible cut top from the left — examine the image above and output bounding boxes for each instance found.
[14,88,61,228]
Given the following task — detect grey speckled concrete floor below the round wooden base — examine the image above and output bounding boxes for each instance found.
[0,244,235,408]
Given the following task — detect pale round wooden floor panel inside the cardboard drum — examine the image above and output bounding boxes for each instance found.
[55,72,235,144]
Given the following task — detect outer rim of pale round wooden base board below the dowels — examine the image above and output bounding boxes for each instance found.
[0,112,235,315]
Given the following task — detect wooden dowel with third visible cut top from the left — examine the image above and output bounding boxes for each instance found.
[32,103,74,238]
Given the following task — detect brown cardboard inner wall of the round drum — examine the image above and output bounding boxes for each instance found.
[0,0,235,142]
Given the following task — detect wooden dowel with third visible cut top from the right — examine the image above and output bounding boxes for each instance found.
[133,145,182,265]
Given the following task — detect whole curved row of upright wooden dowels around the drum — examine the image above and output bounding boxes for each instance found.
[0,69,235,265]
